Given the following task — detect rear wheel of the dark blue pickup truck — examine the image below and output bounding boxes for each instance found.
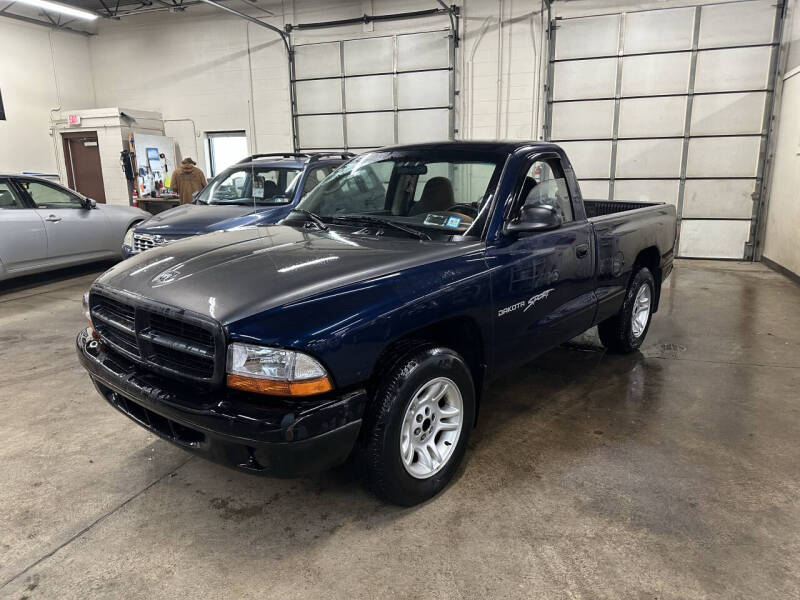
[597,267,656,354]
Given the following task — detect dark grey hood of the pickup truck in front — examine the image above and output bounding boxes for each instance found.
[96,225,479,324]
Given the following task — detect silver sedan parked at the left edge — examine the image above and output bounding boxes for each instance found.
[0,174,150,281]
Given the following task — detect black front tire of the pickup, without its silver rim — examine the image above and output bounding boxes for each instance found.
[361,346,475,506]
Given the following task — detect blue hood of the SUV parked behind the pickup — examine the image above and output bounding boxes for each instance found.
[136,204,290,235]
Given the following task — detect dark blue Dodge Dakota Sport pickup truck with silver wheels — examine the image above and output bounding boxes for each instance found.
[77,142,675,505]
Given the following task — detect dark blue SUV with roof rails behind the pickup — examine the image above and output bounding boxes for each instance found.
[122,152,353,258]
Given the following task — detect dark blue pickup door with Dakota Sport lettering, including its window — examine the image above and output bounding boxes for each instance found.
[487,154,595,367]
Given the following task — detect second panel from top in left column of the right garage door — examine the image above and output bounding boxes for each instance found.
[553,58,617,100]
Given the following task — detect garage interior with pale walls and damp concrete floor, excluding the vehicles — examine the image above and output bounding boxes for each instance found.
[0,0,800,599]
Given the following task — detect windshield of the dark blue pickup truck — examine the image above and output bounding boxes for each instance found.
[298,150,504,235]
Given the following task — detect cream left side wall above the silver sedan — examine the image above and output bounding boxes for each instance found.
[0,18,95,173]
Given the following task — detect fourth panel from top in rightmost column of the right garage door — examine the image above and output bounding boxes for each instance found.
[686,137,761,177]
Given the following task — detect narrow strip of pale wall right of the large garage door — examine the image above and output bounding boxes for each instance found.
[763,0,800,275]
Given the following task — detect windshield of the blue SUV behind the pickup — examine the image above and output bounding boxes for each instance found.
[197,167,302,206]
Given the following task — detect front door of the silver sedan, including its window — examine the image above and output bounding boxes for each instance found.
[18,179,113,259]
